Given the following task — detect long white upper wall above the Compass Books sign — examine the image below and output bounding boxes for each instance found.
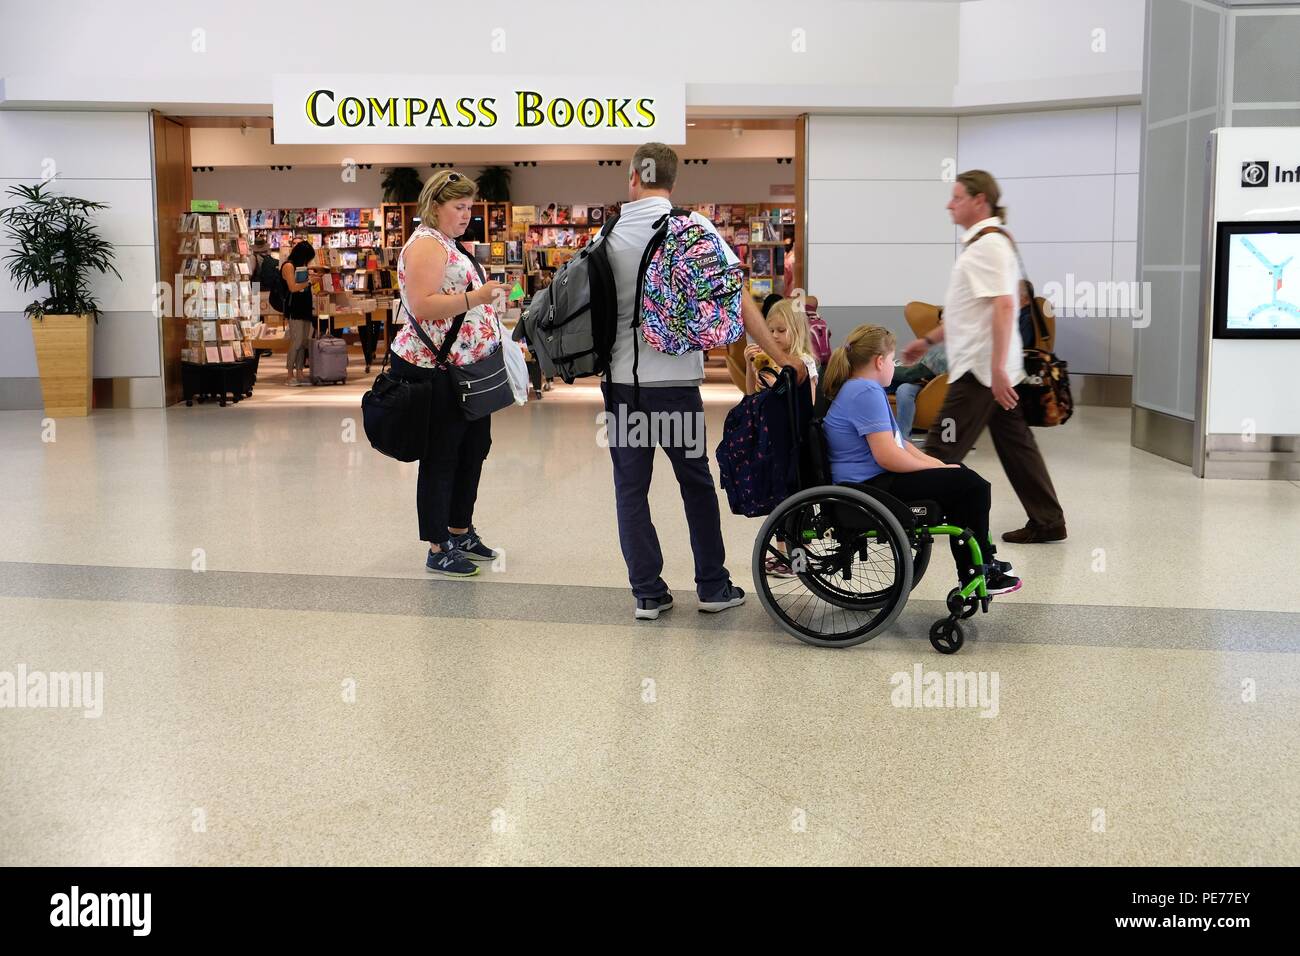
[0,0,1143,113]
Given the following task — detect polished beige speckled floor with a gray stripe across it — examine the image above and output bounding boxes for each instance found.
[0,358,1300,865]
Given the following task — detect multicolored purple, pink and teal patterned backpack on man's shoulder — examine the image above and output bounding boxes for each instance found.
[636,208,745,355]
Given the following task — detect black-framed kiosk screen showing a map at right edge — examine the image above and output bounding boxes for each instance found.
[1214,222,1300,338]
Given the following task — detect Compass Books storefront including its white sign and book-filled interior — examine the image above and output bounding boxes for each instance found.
[149,77,802,406]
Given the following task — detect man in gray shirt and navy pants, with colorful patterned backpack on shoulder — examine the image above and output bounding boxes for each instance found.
[603,143,807,620]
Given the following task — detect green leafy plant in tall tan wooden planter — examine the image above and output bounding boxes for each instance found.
[0,182,122,418]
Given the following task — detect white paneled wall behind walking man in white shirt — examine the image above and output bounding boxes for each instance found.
[807,107,1139,375]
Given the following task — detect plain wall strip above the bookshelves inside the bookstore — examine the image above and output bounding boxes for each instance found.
[194,160,794,208]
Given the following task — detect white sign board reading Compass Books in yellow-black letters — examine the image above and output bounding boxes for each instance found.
[272,73,686,146]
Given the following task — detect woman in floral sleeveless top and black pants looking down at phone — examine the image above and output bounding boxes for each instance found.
[391,169,504,578]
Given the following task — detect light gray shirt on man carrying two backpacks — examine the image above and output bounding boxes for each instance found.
[605,196,740,388]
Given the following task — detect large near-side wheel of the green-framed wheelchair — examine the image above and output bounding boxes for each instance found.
[753,485,915,648]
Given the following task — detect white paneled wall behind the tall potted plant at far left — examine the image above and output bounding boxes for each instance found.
[0,111,163,406]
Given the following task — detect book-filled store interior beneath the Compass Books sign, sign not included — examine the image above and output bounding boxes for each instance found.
[179,128,798,405]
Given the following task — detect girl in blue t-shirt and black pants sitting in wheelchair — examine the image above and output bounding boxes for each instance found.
[822,325,1021,594]
